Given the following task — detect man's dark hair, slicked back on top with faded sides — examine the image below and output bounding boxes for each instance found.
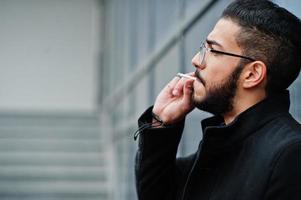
[222,0,301,93]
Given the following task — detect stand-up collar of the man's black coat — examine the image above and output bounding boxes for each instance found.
[201,90,290,150]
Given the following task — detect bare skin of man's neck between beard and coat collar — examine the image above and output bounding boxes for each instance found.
[223,92,266,124]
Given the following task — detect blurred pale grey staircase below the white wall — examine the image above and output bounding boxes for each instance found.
[0,113,109,200]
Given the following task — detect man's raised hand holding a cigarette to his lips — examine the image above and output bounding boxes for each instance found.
[153,74,194,124]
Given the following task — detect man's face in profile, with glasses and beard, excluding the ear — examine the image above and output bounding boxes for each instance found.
[192,19,243,115]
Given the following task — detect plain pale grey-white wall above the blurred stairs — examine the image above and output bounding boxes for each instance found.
[0,0,101,111]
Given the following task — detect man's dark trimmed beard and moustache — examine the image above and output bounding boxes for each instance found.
[193,63,243,115]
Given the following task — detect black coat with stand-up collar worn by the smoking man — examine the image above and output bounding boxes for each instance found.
[135,91,301,200]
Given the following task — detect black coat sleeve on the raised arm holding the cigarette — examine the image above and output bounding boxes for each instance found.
[135,108,193,200]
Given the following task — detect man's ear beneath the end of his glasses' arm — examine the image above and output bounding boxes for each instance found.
[241,61,267,88]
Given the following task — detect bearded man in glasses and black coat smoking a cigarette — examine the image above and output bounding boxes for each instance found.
[136,0,301,200]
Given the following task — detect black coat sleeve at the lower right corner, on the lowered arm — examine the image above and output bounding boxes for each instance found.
[264,142,301,200]
